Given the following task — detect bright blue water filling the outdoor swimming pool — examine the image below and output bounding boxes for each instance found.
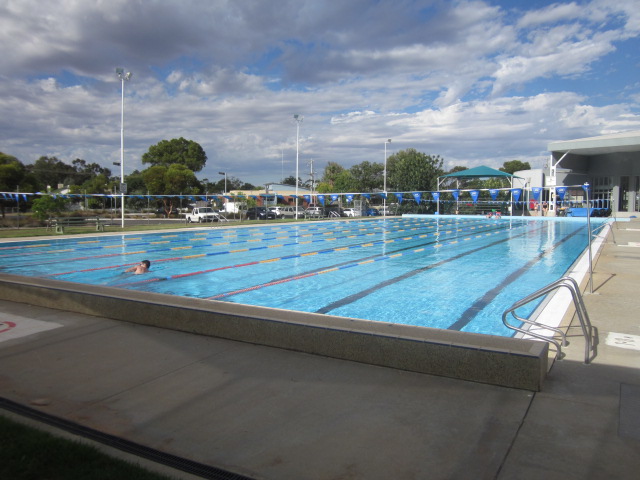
[0,216,600,336]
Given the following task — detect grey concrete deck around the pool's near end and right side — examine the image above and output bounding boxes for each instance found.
[0,219,640,480]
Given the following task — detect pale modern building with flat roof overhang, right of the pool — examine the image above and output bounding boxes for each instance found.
[515,130,640,217]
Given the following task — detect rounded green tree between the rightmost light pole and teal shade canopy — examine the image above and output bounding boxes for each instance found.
[387,148,444,192]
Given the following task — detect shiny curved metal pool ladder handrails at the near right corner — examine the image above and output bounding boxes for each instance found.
[502,277,595,364]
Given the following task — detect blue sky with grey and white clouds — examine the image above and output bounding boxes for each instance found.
[0,0,640,185]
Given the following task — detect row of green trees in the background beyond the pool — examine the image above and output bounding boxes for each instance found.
[0,137,530,214]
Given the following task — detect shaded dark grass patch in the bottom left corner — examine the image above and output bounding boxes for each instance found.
[0,415,176,480]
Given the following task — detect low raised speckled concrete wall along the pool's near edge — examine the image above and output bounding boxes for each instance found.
[0,274,549,391]
